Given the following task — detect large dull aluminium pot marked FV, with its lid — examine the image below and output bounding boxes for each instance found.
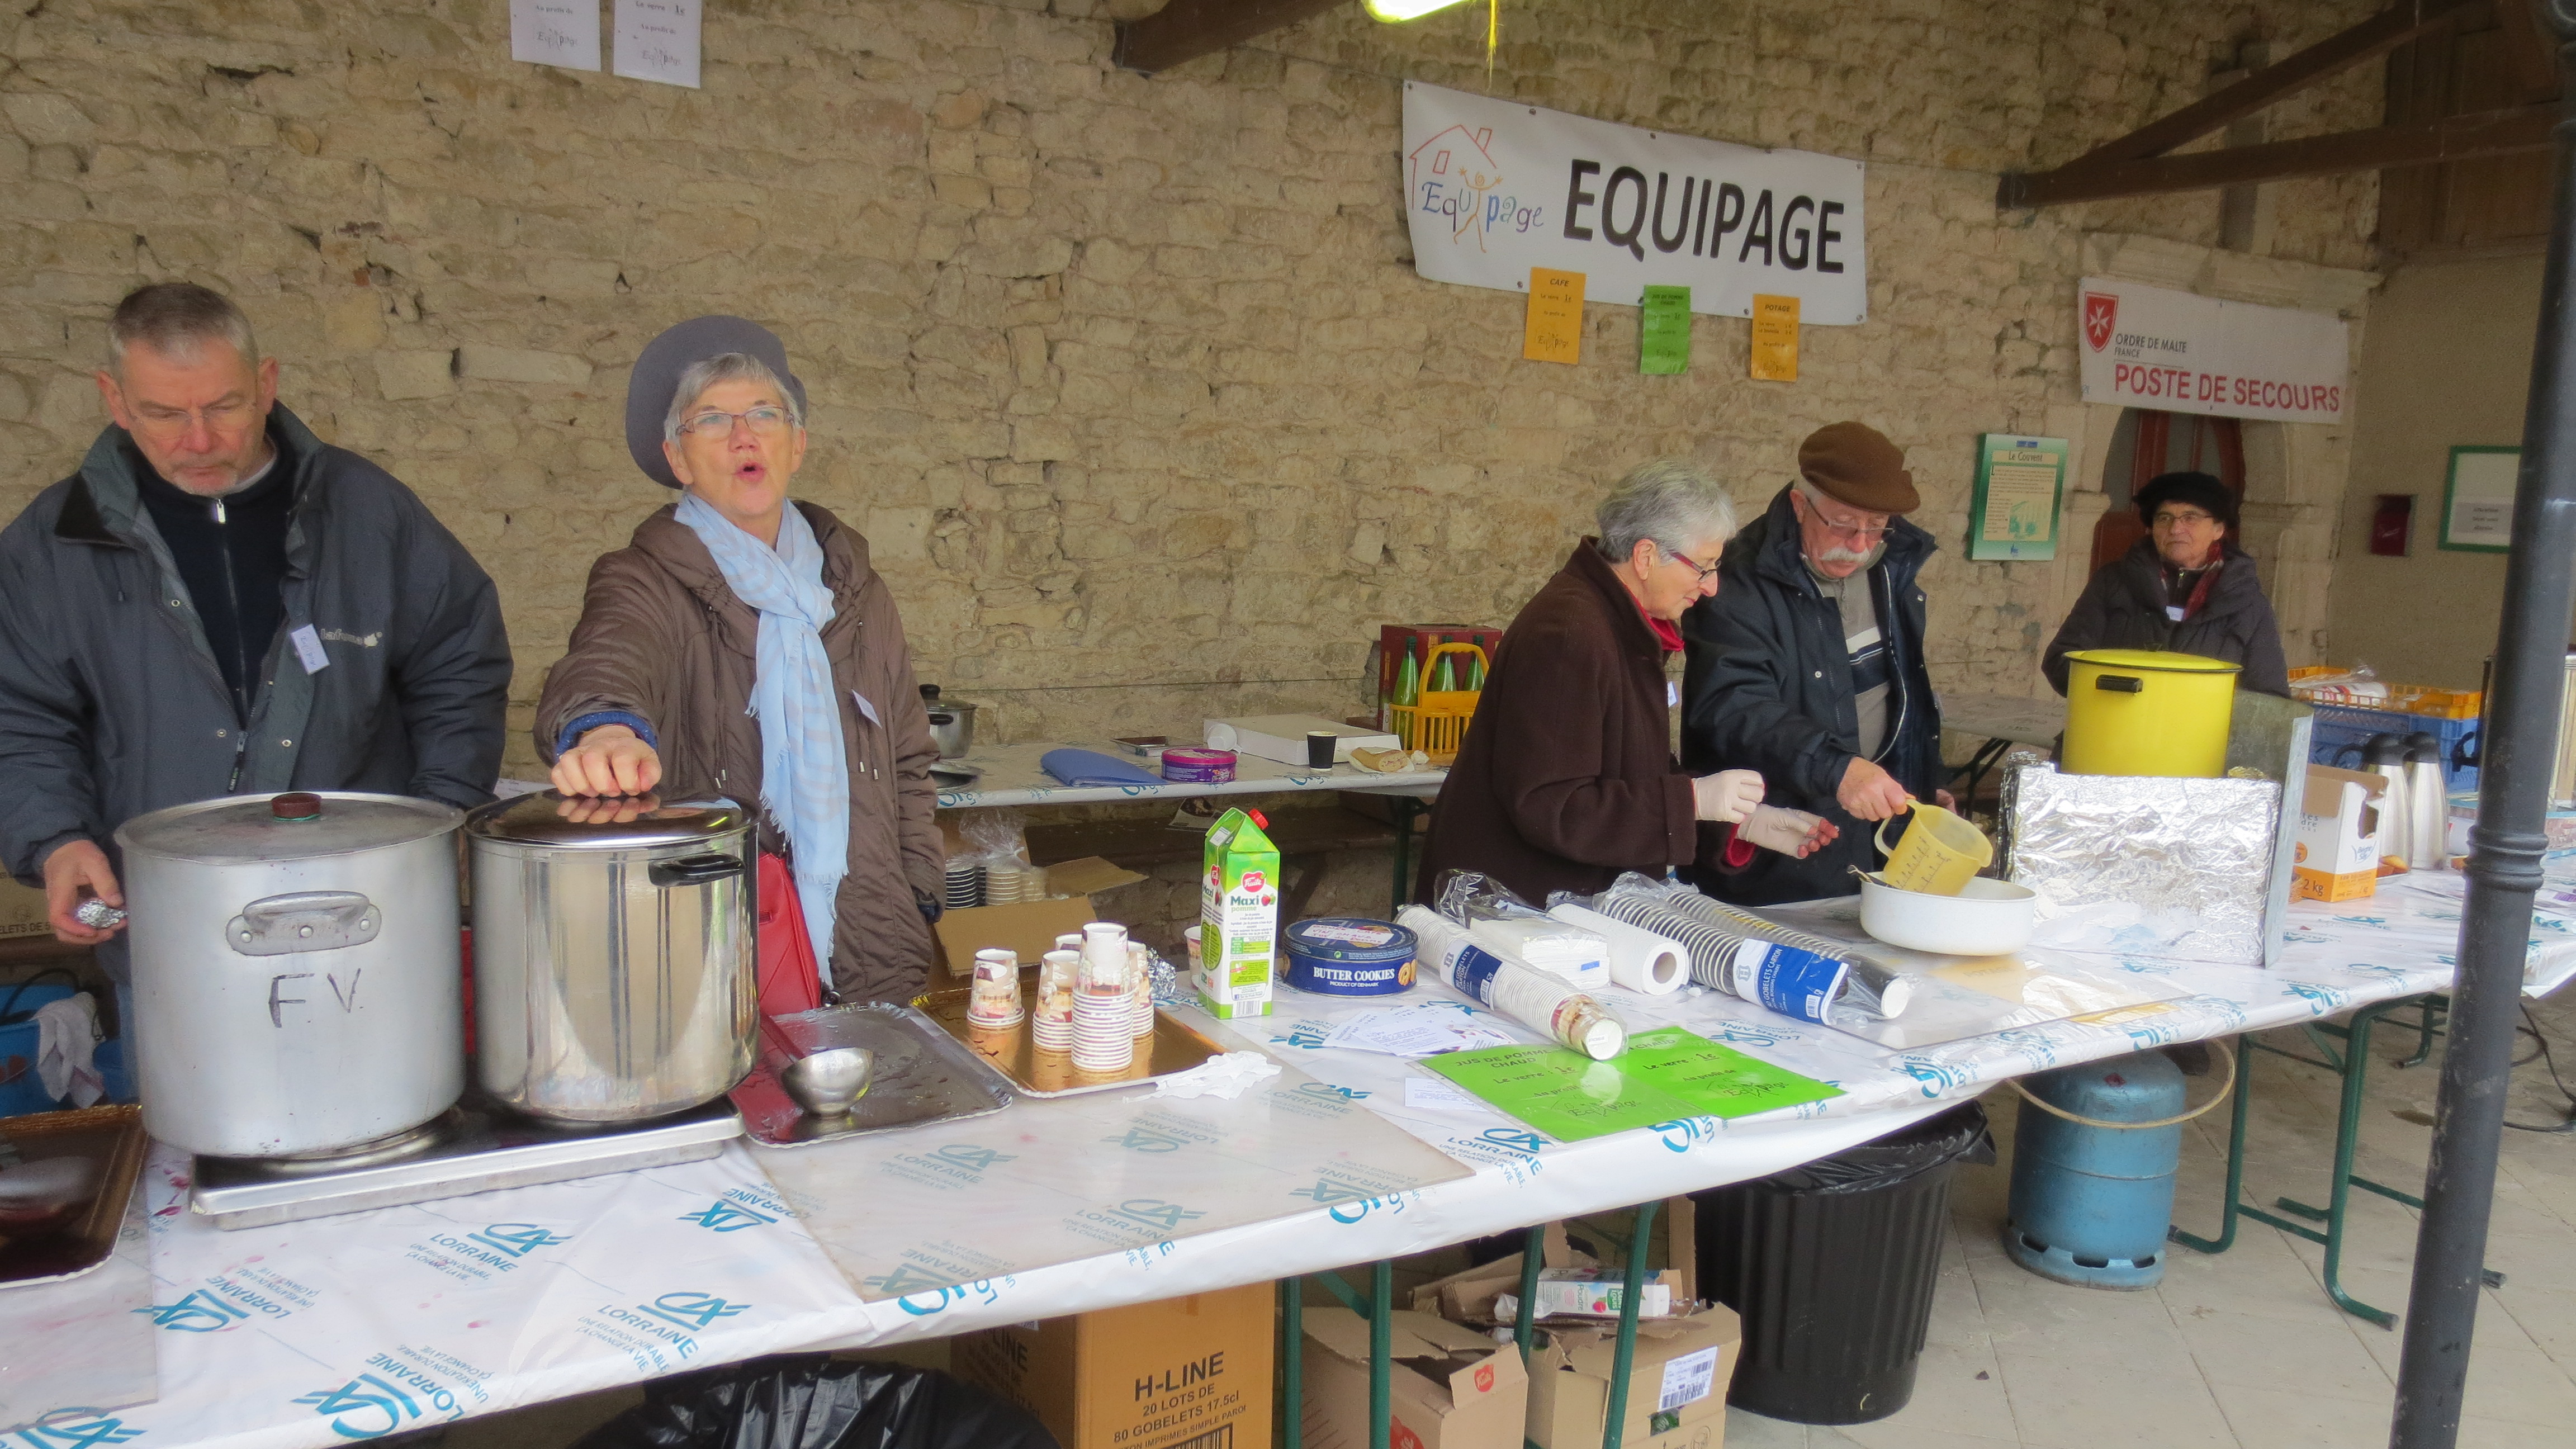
[116,792,466,1158]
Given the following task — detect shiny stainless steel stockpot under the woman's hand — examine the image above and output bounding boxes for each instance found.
[466,789,760,1121]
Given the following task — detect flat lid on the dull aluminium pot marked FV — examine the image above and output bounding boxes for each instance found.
[116,792,463,866]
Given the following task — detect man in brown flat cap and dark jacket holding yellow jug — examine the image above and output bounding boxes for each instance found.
[1682,423,1950,905]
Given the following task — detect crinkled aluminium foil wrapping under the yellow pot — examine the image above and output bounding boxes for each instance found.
[2001,763,2280,967]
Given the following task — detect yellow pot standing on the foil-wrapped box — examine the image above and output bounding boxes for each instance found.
[2058,650,2241,779]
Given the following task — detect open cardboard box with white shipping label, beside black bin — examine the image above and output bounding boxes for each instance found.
[1528,1305,1744,1449]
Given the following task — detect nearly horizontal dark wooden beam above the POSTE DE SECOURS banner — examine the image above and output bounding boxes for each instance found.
[1996,103,2560,206]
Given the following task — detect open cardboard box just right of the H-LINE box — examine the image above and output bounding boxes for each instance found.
[1298,1307,1530,1449]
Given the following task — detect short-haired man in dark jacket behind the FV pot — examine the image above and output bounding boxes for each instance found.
[0,283,510,982]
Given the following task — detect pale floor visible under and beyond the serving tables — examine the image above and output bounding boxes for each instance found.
[404,993,2576,1449]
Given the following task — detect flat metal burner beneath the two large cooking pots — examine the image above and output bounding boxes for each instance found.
[191,1096,742,1227]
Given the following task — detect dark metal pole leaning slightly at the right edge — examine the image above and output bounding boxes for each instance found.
[2388,14,2576,1449]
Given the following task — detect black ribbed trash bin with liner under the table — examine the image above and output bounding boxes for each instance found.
[1690,1101,1994,1423]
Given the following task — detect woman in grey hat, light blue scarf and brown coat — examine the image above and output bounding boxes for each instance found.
[536,317,940,1000]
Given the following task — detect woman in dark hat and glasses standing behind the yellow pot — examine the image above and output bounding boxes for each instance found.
[2040,472,2290,699]
